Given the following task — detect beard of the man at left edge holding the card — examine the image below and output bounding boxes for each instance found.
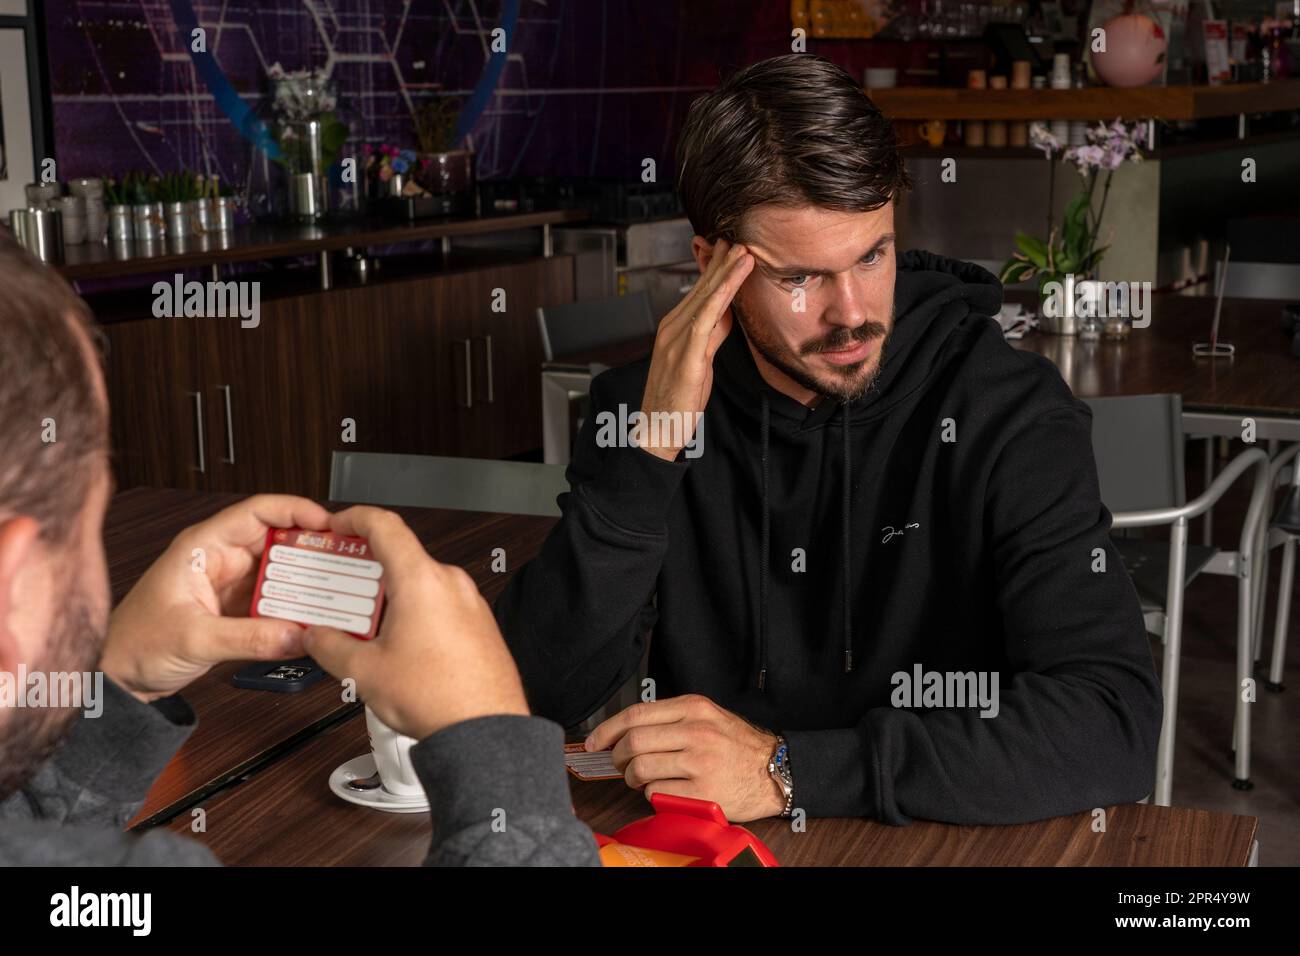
[0,584,108,800]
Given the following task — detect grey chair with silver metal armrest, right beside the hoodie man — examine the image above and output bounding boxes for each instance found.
[1086,395,1269,806]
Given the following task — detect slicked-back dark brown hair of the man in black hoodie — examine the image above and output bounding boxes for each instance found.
[677,53,911,242]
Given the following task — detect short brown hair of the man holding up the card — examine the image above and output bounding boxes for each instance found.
[0,228,108,545]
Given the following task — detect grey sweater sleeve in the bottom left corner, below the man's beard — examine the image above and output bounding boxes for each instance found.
[0,678,216,866]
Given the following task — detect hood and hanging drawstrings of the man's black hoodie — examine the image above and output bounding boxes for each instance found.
[714,250,1002,691]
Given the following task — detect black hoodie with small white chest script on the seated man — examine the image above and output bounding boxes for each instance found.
[497,251,1161,823]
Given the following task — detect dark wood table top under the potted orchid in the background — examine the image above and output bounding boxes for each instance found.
[1008,294,1300,418]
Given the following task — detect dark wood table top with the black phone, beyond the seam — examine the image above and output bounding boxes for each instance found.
[104,488,555,825]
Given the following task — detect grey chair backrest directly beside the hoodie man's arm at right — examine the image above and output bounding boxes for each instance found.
[1084,395,1187,514]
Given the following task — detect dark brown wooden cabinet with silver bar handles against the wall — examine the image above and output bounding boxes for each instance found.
[104,256,573,497]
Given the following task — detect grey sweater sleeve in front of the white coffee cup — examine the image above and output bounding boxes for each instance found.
[411,715,601,866]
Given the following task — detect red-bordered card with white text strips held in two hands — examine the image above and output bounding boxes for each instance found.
[248,528,384,640]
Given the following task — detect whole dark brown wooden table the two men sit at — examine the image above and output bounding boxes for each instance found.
[119,489,1257,866]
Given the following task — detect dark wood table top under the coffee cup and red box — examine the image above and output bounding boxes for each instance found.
[168,717,1258,866]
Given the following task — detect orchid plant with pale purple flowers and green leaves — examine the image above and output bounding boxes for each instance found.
[1000,120,1143,290]
